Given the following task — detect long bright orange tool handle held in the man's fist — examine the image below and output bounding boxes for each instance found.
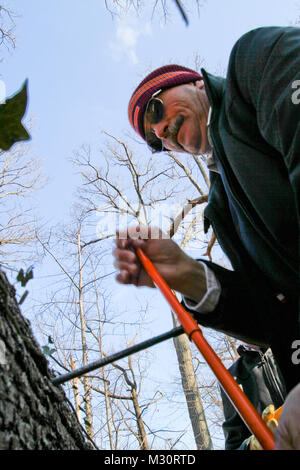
[137,248,275,450]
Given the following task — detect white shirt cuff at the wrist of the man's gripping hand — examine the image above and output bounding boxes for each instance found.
[183,261,222,313]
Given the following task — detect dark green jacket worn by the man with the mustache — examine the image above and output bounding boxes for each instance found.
[186,27,300,388]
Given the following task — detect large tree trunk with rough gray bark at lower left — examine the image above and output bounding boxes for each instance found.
[0,271,92,450]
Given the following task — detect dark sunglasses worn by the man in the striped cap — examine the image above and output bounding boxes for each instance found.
[145,90,166,153]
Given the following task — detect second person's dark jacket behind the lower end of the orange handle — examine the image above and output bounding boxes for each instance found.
[221,346,286,450]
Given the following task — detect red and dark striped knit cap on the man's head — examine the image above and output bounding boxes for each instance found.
[128,64,202,140]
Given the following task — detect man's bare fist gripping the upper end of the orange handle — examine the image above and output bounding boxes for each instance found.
[113,227,206,302]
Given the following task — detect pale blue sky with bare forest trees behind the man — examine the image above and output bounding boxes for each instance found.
[0,0,299,450]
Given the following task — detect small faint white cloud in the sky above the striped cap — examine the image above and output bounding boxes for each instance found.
[110,19,151,64]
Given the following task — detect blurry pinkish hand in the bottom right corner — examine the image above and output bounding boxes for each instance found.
[274,384,300,450]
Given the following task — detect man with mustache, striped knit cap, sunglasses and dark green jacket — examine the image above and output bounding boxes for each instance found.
[114,27,300,448]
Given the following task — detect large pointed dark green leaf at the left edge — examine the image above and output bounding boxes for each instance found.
[0,80,30,150]
